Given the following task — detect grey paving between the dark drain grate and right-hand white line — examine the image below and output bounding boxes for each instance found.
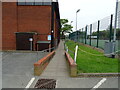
[57,78,101,88]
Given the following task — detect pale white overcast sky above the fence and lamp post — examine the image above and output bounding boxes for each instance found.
[59,0,116,30]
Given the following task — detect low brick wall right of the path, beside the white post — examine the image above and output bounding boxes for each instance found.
[65,51,77,77]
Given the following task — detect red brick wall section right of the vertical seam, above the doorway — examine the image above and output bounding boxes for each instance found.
[18,6,51,41]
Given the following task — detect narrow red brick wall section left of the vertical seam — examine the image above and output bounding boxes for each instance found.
[2,2,17,50]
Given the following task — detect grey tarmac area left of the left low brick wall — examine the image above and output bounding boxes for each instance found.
[2,52,48,88]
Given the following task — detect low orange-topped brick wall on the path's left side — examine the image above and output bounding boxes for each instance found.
[34,51,55,76]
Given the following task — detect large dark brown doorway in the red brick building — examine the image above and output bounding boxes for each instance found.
[16,33,33,50]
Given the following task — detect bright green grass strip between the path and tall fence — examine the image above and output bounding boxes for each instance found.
[66,41,120,73]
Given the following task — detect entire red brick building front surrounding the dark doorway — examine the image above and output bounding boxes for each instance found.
[2,2,51,50]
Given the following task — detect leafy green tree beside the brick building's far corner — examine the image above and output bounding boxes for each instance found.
[60,19,73,37]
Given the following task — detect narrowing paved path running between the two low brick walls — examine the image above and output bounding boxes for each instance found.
[41,41,69,77]
